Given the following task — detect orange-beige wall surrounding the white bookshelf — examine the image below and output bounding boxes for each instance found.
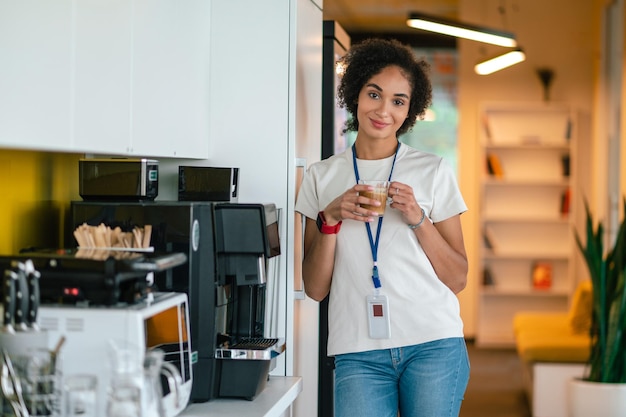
[458,0,603,337]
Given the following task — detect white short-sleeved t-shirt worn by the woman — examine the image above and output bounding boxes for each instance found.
[296,144,467,356]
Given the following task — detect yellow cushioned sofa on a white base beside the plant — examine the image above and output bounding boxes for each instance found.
[513,280,593,417]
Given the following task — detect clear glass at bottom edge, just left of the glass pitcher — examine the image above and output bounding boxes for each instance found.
[63,374,98,417]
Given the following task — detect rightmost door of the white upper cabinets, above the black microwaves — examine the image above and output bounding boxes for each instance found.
[130,0,211,158]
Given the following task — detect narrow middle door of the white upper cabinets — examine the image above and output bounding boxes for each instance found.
[73,0,132,153]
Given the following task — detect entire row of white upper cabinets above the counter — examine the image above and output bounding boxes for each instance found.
[0,0,210,158]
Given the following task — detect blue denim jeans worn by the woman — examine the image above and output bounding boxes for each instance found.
[335,338,469,417]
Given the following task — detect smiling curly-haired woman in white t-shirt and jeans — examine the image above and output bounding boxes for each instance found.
[296,39,469,417]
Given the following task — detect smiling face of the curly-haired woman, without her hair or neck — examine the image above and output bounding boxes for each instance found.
[357,65,411,143]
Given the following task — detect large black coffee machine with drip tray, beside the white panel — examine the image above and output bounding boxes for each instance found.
[67,201,285,402]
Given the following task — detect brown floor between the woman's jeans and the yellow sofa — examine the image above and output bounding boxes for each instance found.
[460,342,530,417]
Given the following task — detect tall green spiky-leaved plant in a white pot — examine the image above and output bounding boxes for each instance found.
[570,199,626,417]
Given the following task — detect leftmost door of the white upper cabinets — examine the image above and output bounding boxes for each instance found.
[0,0,72,149]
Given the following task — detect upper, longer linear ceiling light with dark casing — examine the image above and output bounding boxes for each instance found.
[406,13,517,48]
